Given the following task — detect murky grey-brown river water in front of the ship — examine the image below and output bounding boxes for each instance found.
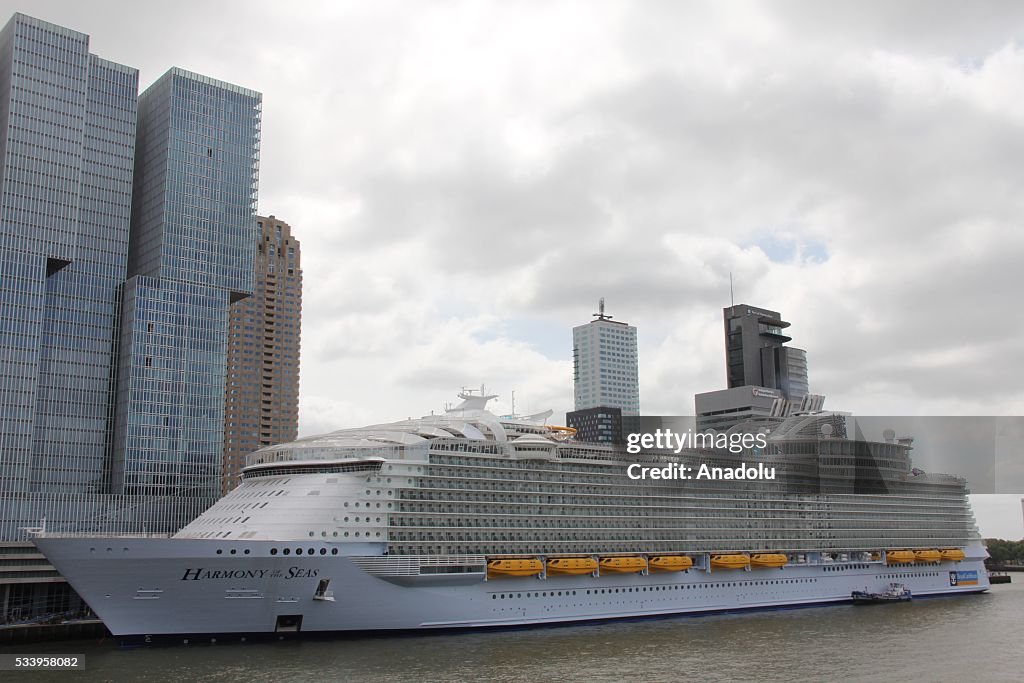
[8,574,1024,683]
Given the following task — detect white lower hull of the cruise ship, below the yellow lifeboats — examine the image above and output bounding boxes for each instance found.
[36,537,988,642]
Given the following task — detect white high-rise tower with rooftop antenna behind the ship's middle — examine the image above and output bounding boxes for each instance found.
[572,299,640,416]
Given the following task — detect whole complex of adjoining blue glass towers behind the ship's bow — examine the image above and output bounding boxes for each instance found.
[0,14,261,544]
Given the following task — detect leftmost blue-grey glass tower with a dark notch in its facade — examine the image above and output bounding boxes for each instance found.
[0,14,138,541]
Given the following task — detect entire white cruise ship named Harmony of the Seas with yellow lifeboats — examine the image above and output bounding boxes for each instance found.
[35,390,988,643]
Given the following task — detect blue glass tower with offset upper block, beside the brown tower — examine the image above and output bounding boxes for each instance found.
[113,69,261,511]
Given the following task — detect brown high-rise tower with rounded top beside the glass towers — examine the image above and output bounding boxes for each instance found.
[221,216,302,494]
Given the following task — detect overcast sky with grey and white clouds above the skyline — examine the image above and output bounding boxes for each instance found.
[8,0,1024,532]
